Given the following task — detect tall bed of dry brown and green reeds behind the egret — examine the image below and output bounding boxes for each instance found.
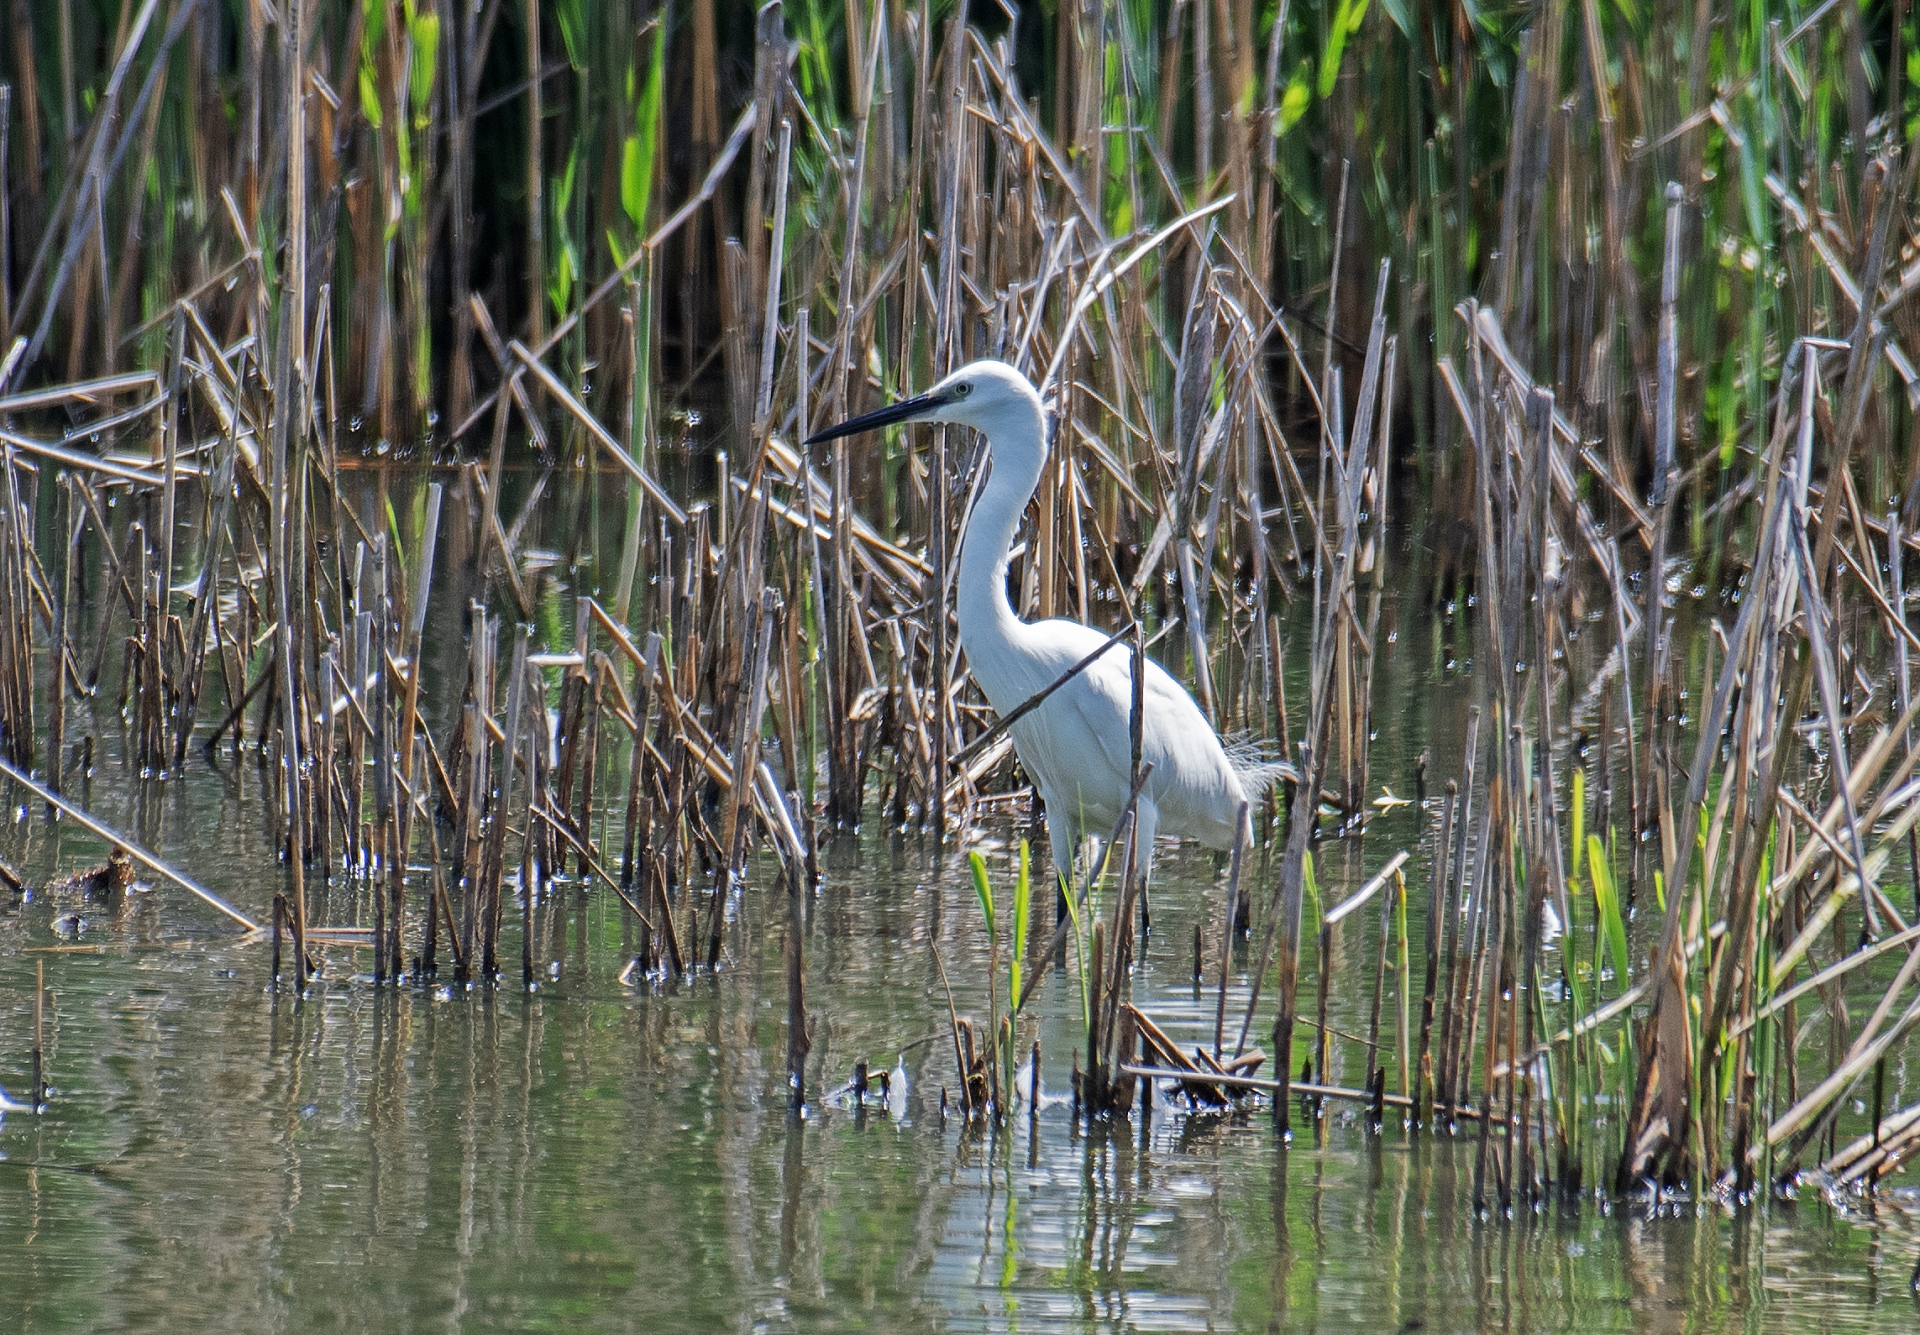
[0,0,1920,1206]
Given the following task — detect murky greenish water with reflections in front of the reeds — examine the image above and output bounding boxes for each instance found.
[0,485,1920,1331]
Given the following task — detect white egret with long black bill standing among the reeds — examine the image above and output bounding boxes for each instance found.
[806,361,1292,880]
